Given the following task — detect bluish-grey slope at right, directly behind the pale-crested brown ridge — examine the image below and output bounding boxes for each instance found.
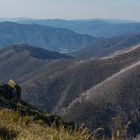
[69,34,140,59]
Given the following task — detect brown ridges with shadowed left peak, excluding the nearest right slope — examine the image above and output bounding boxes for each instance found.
[0,45,140,115]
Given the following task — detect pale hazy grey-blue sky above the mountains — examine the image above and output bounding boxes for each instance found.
[0,0,140,20]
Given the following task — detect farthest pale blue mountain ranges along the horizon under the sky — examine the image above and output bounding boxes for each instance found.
[5,18,140,38]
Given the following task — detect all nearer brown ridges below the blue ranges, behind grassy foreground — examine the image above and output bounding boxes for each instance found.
[0,44,140,138]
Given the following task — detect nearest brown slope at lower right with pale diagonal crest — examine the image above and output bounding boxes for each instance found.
[64,61,140,133]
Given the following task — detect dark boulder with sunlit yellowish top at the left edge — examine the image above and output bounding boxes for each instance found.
[0,80,21,100]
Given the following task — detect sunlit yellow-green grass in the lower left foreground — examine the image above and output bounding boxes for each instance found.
[0,109,90,140]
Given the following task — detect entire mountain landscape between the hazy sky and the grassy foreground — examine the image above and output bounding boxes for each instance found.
[0,19,140,138]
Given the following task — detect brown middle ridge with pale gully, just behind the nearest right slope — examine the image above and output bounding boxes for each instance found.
[22,46,140,112]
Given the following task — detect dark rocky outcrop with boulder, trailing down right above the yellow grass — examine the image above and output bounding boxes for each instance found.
[0,80,77,134]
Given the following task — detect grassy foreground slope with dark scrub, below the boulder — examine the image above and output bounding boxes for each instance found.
[0,100,139,140]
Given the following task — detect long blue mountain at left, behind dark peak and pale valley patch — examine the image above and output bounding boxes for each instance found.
[0,22,96,51]
